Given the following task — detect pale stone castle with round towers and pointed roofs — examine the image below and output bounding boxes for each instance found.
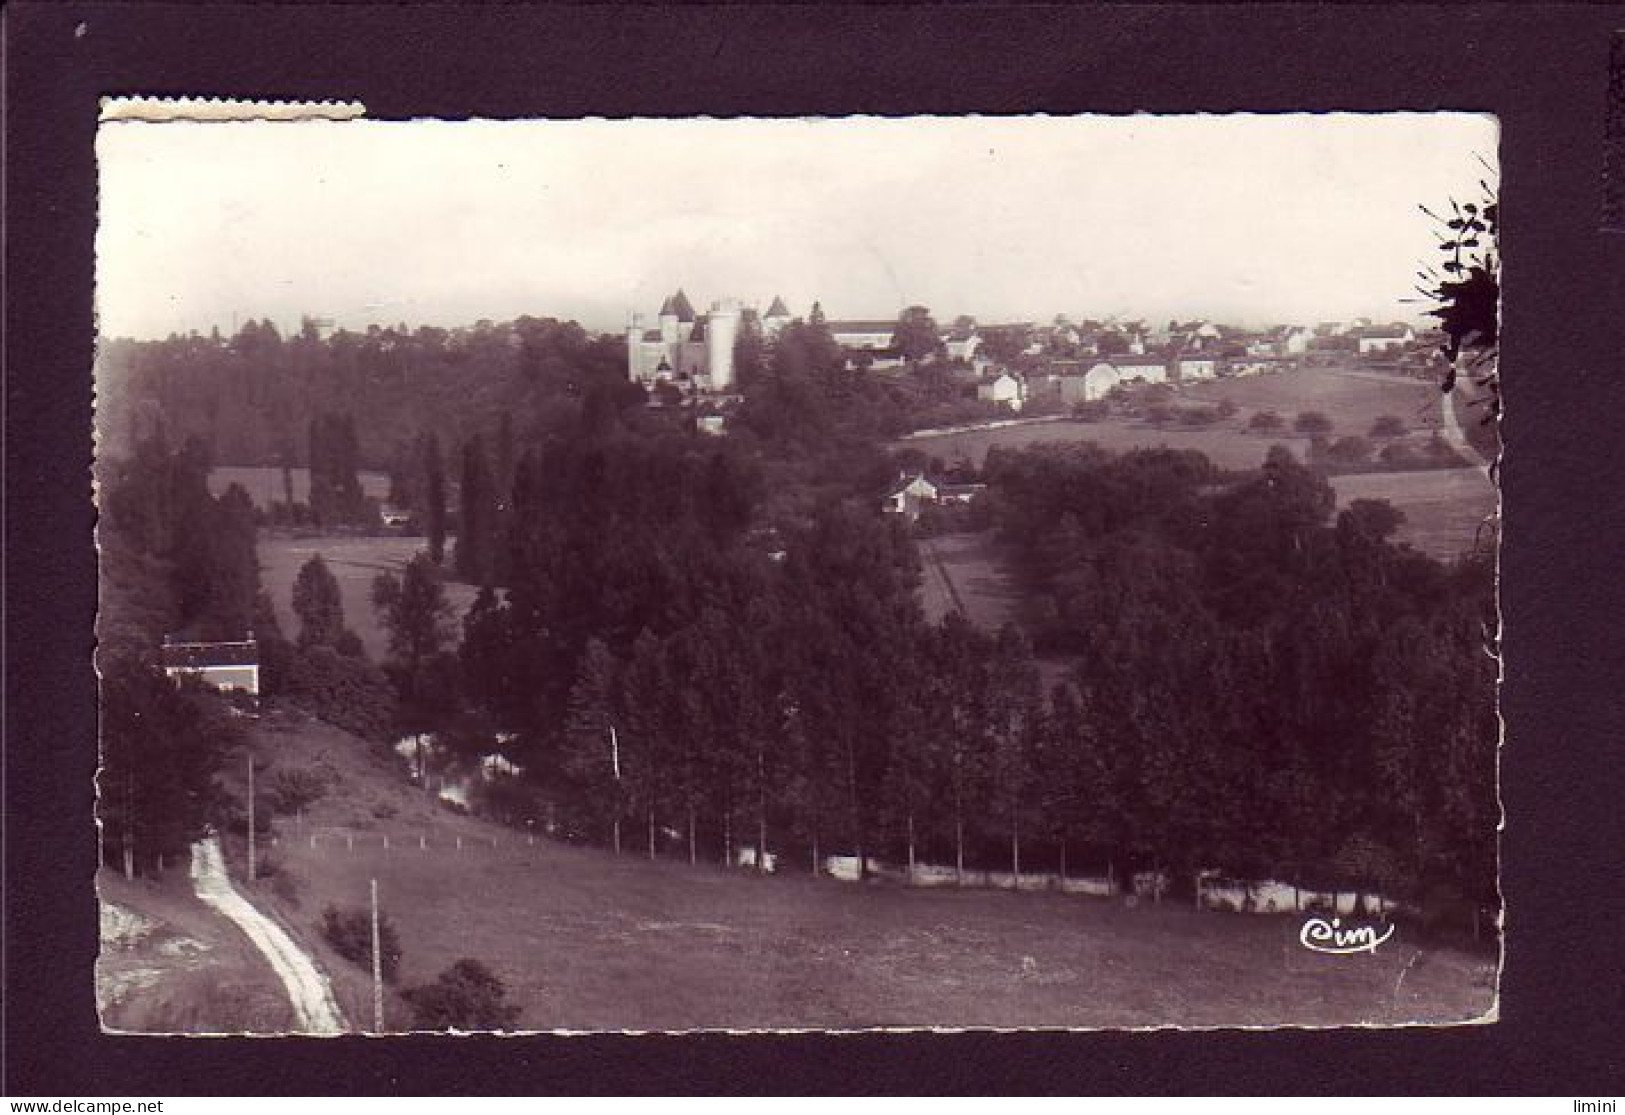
[626,289,790,393]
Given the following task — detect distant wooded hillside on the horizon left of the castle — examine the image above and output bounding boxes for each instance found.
[98,317,642,471]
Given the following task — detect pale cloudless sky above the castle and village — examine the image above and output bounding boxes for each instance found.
[96,114,1498,336]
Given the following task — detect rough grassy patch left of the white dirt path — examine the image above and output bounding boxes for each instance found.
[96,863,294,1034]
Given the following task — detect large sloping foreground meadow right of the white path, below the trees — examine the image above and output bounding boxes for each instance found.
[232,720,1493,1030]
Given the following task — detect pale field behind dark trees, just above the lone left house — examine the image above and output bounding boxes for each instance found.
[258,530,478,662]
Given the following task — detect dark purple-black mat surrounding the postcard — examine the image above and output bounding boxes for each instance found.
[3,3,1625,1110]
